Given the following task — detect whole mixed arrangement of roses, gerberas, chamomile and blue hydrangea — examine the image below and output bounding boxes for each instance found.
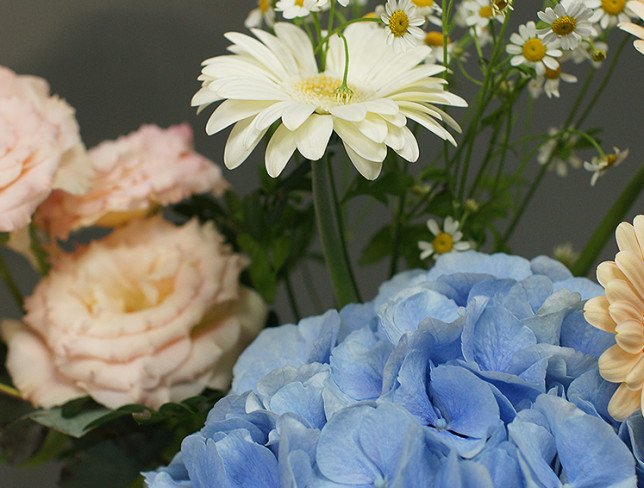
[0,0,644,488]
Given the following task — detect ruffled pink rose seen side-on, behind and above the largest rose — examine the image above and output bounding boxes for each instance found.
[36,124,228,239]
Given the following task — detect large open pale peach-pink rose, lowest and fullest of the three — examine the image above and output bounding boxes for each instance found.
[2,217,266,408]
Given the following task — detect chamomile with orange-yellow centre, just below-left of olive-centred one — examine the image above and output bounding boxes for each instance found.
[506,21,562,76]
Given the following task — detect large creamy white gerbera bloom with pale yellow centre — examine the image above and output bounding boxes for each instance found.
[192,23,467,179]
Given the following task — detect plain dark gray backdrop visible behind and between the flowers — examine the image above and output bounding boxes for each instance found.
[0,0,644,487]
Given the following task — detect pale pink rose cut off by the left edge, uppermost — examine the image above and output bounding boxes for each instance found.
[0,66,90,232]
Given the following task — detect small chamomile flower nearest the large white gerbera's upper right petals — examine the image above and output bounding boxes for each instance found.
[380,0,425,53]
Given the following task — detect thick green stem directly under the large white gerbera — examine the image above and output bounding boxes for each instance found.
[311,154,359,307]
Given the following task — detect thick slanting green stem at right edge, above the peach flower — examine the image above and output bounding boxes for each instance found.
[572,168,644,276]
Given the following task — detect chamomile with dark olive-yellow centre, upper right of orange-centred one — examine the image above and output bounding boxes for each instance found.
[537,0,597,50]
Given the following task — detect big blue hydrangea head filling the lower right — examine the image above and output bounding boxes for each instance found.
[145,251,644,488]
